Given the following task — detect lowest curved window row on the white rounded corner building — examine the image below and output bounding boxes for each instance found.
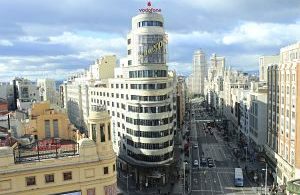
[127,150,173,162]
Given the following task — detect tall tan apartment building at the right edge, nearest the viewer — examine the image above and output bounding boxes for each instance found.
[265,42,300,185]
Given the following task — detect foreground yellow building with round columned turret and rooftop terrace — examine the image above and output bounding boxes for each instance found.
[0,104,116,195]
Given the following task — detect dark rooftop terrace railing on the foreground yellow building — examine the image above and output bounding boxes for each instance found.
[14,141,79,163]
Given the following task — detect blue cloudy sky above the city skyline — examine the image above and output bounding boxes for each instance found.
[0,0,300,81]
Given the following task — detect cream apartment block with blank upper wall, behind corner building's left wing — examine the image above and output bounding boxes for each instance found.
[59,55,117,131]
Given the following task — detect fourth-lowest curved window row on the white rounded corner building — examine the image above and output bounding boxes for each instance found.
[126,116,173,126]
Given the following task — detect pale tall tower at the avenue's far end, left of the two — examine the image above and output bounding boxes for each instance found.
[192,50,207,95]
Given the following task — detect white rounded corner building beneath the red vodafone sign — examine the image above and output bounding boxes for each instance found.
[89,9,176,188]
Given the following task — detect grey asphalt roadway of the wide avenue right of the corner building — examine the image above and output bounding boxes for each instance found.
[191,103,256,195]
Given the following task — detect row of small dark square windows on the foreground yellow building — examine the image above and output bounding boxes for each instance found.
[25,164,116,186]
